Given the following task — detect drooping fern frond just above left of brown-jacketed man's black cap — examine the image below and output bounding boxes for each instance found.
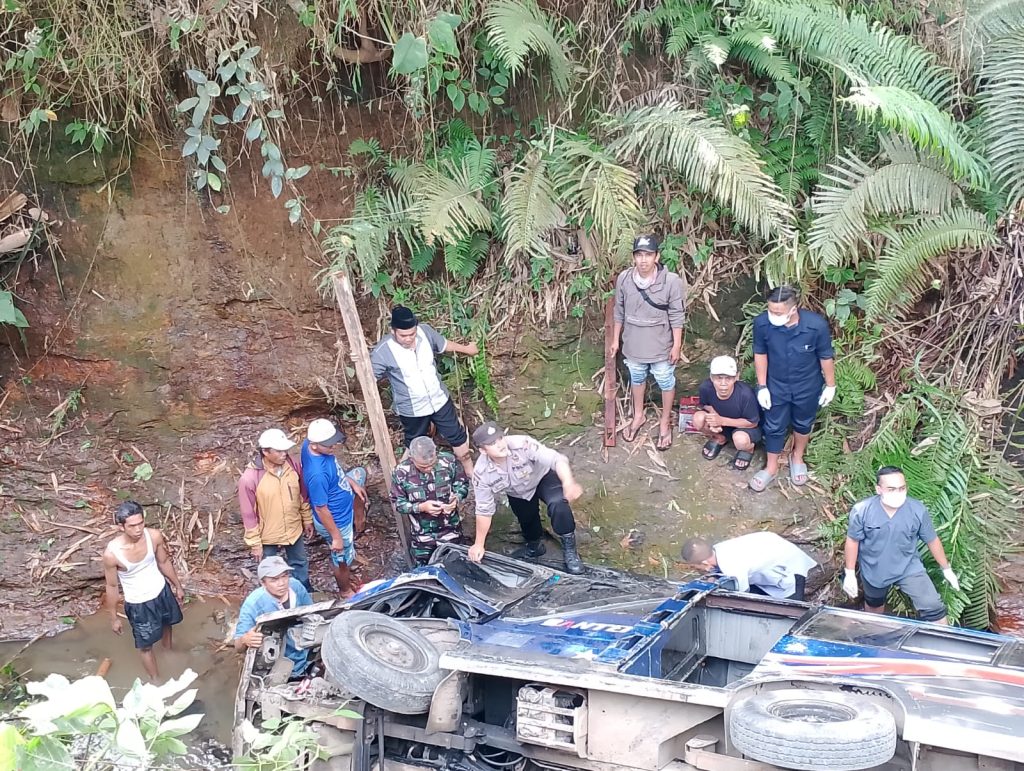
[552,136,643,254]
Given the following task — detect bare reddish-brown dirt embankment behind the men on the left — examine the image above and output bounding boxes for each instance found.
[0,118,411,639]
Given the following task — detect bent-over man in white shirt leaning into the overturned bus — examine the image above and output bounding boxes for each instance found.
[682,530,817,600]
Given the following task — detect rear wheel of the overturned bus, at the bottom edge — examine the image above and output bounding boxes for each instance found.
[729,688,896,771]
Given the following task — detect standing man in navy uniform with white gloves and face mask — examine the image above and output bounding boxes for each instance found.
[750,287,836,492]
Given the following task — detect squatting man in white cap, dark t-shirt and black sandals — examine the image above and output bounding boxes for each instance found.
[693,356,761,471]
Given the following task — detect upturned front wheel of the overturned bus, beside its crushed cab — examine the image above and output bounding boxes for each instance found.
[321,610,446,715]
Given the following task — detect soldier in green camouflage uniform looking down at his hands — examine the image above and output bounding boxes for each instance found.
[391,436,469,565]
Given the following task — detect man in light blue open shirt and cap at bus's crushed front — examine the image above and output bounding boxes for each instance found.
[234,555,313,678]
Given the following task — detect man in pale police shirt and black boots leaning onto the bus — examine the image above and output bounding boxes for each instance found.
[469,421,583,573]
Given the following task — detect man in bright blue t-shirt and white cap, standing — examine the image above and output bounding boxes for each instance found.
[302,418,367,597]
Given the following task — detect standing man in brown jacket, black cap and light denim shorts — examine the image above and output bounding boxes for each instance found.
[611,235,686,449]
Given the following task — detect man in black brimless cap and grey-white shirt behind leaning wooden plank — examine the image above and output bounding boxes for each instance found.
[370,305,479,476]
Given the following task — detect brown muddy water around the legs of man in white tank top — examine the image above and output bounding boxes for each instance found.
[0,599,241,746]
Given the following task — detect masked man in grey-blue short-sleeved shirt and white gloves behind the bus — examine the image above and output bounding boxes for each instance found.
[843,466,959,624]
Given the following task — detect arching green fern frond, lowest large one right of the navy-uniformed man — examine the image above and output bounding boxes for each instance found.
[865,208,997,316]
